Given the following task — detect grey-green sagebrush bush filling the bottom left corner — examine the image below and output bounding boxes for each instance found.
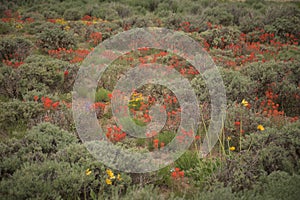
[1,161,86,199]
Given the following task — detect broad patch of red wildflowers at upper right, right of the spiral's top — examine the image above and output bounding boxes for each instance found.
[203,25,298,67]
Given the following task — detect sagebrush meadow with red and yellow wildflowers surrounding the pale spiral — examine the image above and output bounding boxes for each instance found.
[0,0,300,200]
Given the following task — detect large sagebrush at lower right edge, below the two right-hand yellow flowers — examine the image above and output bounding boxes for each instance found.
[213,122,300,191]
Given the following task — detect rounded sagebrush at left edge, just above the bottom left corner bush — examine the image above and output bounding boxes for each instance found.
[1,123,77,177]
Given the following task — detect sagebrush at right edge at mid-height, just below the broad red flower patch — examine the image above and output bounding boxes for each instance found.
[242,59,300,115]
